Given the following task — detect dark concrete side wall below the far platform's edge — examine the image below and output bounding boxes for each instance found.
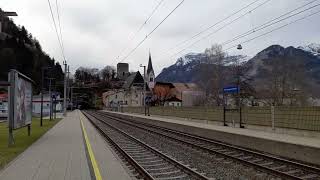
[106,114,320,165]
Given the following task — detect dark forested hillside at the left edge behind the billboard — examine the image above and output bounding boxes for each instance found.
[0,9,63,91]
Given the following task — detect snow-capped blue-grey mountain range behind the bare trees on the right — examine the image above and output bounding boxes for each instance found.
[156,44,320,95]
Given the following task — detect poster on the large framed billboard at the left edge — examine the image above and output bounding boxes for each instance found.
[9,70,32,129]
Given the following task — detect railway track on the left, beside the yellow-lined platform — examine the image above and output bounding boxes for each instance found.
[83,112,209,180]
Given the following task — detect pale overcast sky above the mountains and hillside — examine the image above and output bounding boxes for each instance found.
[0,0,320,74]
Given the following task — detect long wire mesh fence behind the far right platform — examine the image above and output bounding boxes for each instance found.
[122,107,320,131]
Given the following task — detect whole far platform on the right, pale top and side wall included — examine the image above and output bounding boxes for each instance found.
[104,110,320,165]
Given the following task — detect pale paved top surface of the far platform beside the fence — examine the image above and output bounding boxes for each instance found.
[107,111,320,148]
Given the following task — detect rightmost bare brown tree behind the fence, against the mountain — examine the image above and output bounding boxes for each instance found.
[266,57,308,106]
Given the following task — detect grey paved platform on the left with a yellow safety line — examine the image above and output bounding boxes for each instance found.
[0,110,132,180]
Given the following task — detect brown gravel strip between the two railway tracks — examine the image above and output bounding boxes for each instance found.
[102,115,274,179]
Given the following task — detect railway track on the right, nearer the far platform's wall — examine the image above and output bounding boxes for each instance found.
[87,112,320,180]
